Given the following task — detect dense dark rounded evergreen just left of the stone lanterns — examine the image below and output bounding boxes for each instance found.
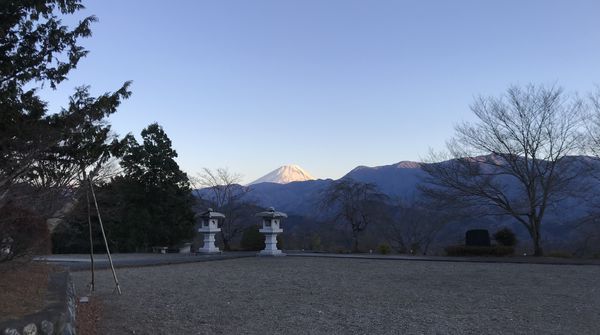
[103,123,195,251]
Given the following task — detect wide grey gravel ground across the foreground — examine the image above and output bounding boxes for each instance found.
[73,257,600,334]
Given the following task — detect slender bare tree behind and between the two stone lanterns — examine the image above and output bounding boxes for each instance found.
[192,168,250,251]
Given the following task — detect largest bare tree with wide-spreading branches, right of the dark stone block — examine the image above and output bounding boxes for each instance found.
[423,85,585,256]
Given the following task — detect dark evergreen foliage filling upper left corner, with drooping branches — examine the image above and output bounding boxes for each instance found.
[0,0,130,258]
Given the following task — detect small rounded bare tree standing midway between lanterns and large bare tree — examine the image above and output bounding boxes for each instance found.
[322,179,387,252]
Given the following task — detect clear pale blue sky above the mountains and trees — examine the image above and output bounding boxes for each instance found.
[43,0,600,182]
